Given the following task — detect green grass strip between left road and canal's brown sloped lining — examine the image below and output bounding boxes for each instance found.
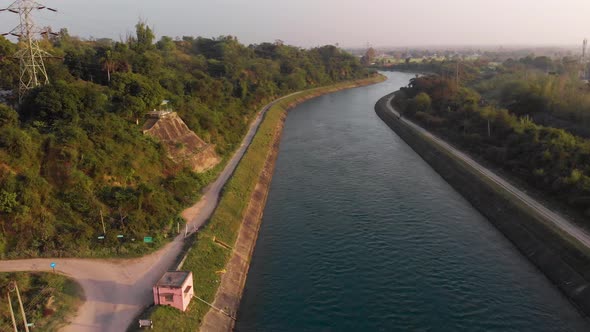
[130,75,385,332]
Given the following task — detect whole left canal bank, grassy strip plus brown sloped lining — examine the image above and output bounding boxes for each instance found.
[142,76,385,331]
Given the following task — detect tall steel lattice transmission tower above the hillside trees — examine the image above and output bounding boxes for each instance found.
[0,0,57,100]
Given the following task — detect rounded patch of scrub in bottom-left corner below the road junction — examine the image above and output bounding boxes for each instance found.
[0,273,82,332]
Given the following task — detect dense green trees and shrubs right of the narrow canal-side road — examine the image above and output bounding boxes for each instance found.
[394,57,590,223]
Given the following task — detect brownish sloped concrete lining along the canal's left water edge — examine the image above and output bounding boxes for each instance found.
[200,76,385,332]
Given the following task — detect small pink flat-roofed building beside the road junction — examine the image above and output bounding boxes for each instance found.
[154,271,194,311]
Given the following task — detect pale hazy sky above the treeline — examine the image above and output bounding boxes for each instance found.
[0,0,590,47]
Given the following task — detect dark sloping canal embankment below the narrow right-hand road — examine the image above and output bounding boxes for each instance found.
[375,94,590,316]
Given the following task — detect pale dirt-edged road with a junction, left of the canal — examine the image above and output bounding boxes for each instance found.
[0,95,290,332]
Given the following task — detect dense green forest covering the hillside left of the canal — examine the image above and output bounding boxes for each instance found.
[0,23,366,258]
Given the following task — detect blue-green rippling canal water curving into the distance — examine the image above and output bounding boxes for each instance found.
[236,73,590,332]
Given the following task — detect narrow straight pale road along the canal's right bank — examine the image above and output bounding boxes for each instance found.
[387,96,590,248]
